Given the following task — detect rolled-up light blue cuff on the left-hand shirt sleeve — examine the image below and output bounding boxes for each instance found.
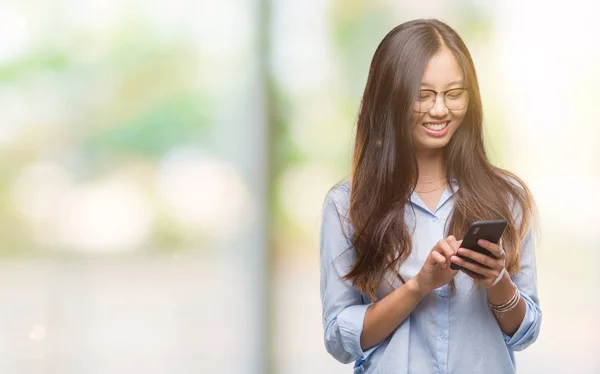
[337,304,381,361]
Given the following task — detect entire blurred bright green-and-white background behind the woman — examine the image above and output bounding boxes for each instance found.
[0,0,600,374]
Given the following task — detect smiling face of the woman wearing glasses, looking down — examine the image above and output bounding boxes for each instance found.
[411,47,468,150]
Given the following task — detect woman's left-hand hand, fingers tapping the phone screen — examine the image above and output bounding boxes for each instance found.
[414,235,462,295]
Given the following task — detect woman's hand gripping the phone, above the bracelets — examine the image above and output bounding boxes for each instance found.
[450,239,506,288]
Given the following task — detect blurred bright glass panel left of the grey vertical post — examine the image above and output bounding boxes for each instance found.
[0,0,267,373]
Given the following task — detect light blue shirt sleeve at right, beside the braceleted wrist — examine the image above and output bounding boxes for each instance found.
[504,230,542,351]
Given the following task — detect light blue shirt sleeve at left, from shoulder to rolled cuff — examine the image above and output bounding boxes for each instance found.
[320,186,378,363]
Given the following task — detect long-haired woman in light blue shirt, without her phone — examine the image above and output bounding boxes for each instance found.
[320,20,542,374]
